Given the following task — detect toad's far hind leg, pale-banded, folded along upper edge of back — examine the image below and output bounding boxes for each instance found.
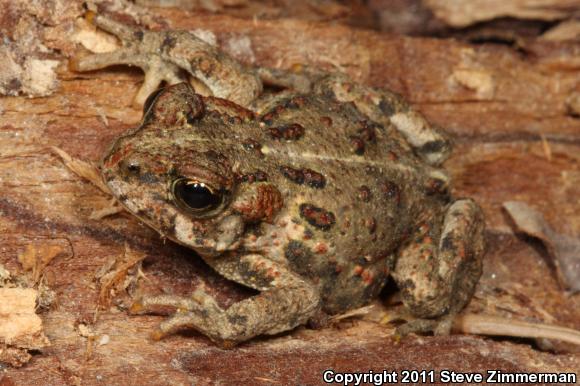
[314,74,451,165]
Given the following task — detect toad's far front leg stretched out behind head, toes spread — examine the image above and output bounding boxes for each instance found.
[70,12,262,107]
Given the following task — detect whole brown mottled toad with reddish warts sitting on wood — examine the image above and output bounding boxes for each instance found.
[74,12,484,346]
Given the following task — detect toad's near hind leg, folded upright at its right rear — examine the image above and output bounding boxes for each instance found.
[393,199,485,332]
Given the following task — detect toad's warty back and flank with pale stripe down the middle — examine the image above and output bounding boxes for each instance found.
[154,95,454,313]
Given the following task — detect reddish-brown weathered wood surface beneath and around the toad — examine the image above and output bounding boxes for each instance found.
[0,0,580,385]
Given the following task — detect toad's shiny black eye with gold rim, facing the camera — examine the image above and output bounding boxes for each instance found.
[171,178,223,215]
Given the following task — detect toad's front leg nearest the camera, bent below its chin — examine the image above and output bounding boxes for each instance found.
[132,255,320,347]
